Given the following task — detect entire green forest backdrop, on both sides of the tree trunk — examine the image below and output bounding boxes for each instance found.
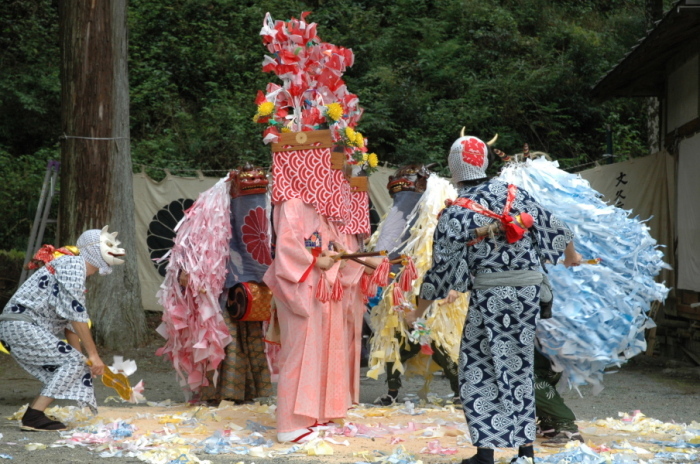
[0,0,671,254]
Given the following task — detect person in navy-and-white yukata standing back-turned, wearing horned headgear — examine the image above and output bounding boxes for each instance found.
[408,135,581,464]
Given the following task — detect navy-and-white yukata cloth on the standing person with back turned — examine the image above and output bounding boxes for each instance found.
[421,180,573,448]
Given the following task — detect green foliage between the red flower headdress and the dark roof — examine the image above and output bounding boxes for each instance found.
[336,0,644,169]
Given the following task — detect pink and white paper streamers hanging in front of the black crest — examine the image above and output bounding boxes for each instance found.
[156,178,231,391]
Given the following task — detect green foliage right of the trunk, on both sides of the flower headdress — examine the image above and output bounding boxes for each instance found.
[130,0,644,169]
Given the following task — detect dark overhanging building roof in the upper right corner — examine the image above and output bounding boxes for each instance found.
[593,0,700,99]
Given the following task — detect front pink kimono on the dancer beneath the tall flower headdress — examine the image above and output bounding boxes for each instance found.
[264,198,359,433]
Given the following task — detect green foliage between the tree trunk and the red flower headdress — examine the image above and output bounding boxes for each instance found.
[129,0,303,169]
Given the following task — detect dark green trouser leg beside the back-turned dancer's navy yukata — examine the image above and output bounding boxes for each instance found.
[535,350,578,433]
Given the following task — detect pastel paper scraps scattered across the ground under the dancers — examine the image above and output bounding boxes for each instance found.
[5,402,700,464]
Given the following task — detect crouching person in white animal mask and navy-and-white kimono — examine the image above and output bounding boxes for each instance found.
[0,226,124,431]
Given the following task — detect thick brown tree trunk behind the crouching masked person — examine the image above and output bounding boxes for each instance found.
[59,0,147,348]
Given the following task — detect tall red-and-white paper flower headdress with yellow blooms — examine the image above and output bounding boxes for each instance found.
[253,12,379,173]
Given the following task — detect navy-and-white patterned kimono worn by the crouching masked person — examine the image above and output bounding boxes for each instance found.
[0,255,97,412]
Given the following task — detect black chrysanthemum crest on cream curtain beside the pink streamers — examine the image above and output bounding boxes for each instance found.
[146,198,194,277]
